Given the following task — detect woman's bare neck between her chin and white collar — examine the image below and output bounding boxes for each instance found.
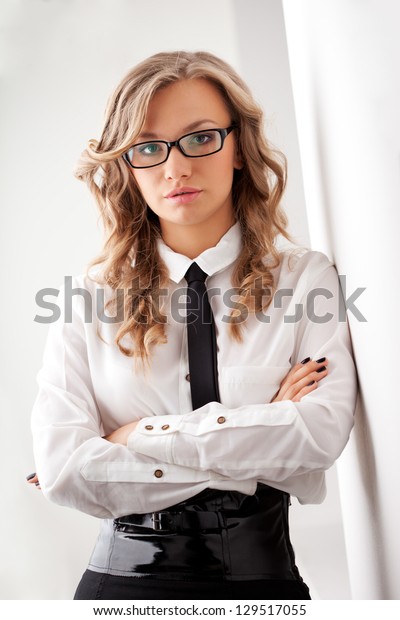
[161,217,235,258]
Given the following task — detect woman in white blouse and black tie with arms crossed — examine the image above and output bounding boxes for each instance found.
[32,52,356,600]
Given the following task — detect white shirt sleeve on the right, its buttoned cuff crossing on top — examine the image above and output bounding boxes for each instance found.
[128,255,357,495]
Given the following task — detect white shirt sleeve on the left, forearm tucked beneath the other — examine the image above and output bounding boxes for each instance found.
[32,280,233,518]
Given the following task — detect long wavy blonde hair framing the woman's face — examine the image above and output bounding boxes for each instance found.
[76,51,290,362]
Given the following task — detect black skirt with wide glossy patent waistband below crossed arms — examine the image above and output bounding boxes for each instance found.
[75,484,310,600]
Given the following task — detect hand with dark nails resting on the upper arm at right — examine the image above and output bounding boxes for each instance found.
[271,357,328,403]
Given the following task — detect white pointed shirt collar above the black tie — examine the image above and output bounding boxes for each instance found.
[157,222,242,284]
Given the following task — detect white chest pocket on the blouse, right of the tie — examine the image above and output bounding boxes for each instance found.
[219,366,291,407]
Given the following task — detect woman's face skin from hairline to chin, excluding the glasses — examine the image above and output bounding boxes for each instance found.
[131,79,241,248]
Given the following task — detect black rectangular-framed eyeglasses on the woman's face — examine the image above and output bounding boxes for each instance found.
[122,125,236,168]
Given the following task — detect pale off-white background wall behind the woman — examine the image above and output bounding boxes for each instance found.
[0,0,348,599]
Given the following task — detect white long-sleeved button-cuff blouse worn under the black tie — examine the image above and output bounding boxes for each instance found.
[32,224,357,518]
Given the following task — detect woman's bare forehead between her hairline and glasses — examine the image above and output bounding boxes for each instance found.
[141,78,230,137]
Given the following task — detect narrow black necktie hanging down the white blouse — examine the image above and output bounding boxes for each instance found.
[185,263,219,409]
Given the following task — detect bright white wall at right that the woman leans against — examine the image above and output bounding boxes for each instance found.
[284,0,400,600]
